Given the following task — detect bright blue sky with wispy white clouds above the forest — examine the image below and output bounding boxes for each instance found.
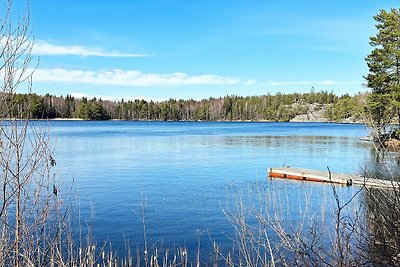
[21,0,399,100]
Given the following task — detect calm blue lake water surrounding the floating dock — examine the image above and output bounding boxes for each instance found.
[44,121,373,258]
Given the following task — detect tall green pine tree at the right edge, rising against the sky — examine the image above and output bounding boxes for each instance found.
[365,9,400,129]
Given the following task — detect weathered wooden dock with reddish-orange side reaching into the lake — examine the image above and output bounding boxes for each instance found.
[268,167,400,188]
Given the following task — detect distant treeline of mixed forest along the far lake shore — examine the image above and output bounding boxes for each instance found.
[2,91,366,121]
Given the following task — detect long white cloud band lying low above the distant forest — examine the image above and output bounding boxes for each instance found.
[33,68,240,87]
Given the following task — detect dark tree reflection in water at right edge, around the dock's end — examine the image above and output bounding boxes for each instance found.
[360,150,400,266]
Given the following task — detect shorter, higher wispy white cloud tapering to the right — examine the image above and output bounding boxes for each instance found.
[32,41,148,57]
